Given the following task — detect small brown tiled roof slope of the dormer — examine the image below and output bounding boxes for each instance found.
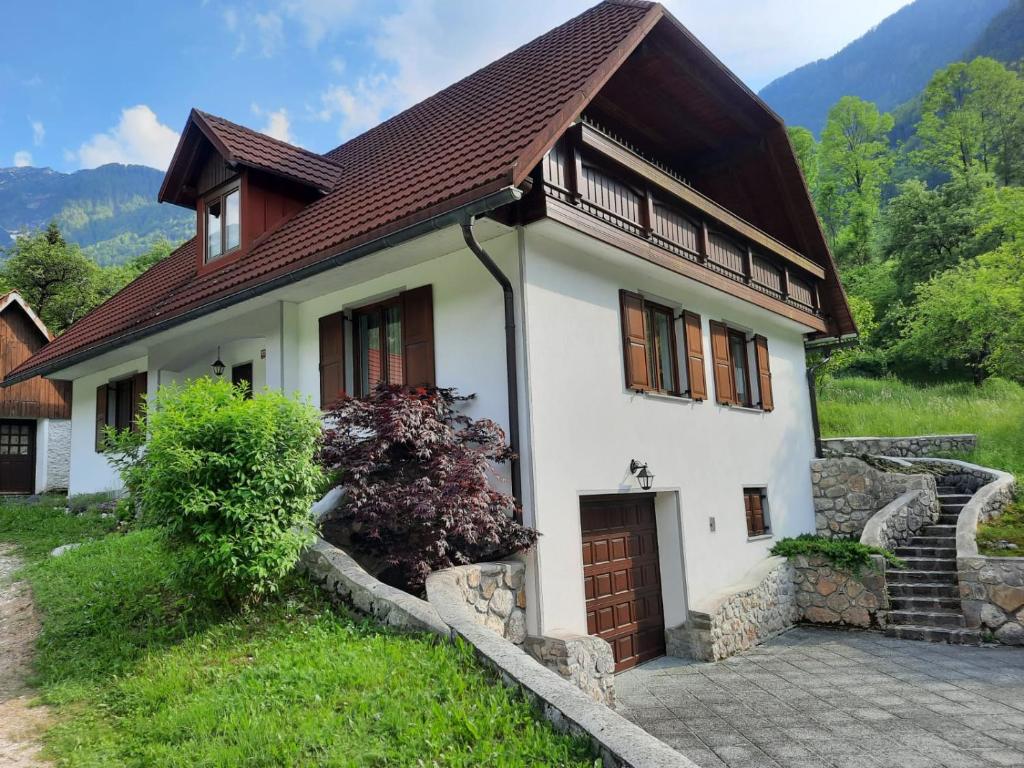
[194,110,341,191]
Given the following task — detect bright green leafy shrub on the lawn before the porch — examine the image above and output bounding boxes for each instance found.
[111,378,321,603]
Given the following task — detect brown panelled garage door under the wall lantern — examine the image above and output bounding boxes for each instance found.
[580,495,665,672]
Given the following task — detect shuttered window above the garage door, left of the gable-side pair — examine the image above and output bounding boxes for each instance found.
[620,291,707,400]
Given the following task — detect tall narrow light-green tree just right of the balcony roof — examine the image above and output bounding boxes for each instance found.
[817,96,893,264]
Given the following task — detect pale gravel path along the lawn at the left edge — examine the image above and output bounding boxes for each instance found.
[0,545,49,768]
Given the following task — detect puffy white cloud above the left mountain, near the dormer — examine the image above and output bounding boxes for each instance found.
[75,104,178,170]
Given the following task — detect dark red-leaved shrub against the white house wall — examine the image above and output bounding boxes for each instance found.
[321,387,537,591]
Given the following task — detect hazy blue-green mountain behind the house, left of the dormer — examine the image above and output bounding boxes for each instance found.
[0,164,196,265]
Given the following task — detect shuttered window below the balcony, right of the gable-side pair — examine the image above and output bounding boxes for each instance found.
[709,321,775,411]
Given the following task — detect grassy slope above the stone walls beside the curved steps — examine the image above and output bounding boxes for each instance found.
[818,378,1024,478]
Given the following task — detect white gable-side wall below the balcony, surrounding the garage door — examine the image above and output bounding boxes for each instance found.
[524,222,814,632]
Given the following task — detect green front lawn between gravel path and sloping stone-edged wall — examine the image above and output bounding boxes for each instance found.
[0,502,594,768]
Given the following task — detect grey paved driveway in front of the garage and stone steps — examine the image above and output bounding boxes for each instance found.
[615,629,1024,768]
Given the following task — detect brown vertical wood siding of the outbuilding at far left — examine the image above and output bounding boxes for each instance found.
[0,304,71,419]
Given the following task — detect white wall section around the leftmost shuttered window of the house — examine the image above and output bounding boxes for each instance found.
[68,357,147,496]
